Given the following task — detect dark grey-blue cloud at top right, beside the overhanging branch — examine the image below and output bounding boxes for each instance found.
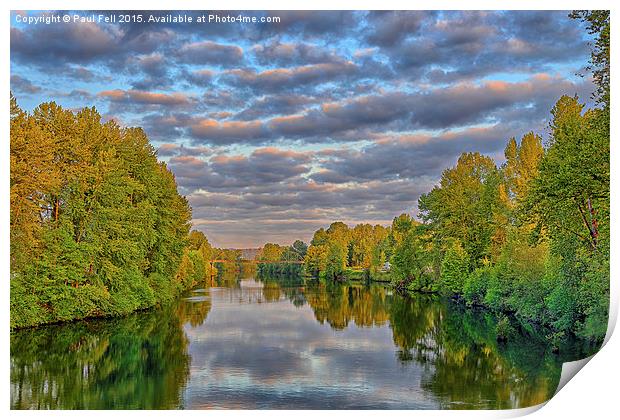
[382,11,587,82]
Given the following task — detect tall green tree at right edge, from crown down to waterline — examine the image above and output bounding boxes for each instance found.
[525,96,610,338]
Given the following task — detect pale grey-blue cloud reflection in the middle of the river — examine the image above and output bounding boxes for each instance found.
[184,284,436,408]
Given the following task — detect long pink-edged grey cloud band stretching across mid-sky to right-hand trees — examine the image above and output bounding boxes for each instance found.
[133,74,591,145]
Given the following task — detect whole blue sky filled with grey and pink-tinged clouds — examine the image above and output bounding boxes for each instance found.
[11,11,593,247]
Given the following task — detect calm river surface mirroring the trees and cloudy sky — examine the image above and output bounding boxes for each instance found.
[11,278,582,409]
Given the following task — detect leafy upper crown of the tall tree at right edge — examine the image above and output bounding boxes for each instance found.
[527,96,610,249]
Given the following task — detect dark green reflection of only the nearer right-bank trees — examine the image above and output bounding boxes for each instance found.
[390,297,561,408]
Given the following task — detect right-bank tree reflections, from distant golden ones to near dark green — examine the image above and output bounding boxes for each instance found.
[298,283,572,408]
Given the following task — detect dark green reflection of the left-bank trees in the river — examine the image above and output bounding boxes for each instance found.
[11,307,194,409]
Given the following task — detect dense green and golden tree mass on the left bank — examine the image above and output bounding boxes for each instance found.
[10,97,206,327]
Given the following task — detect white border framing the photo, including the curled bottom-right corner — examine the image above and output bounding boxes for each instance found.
[0,0,620,420]
